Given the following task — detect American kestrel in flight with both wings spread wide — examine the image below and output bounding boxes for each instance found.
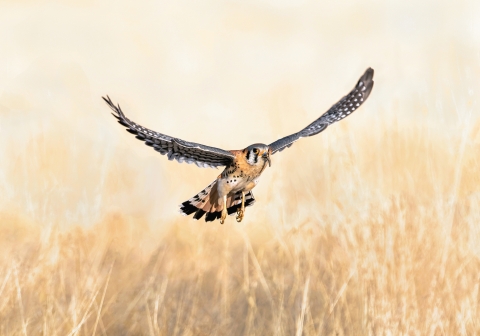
[103,68,373,224]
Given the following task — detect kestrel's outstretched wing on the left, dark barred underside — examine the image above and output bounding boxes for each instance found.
[102,96,235,168]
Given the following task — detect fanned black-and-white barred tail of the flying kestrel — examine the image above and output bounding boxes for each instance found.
[180,180,255,222]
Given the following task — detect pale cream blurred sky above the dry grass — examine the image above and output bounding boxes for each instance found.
[0,0,480,225]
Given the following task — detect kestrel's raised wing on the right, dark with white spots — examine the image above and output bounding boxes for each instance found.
[270,68,373,154]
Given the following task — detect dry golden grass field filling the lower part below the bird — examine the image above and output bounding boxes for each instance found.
[0,115,480,335]
